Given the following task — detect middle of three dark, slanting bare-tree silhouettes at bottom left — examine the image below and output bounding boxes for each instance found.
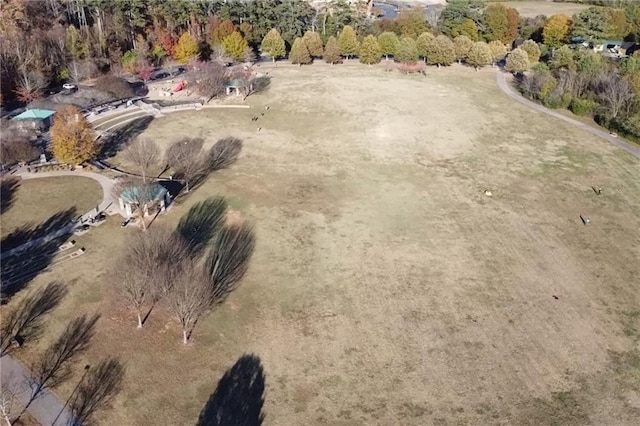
[23,315,100,417]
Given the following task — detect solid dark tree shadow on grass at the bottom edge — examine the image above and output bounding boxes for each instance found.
[196,355,265,426]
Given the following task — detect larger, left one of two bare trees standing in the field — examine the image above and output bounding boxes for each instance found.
[116,226,188,328]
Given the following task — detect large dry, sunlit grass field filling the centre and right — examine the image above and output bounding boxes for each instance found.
[10,63,640,426]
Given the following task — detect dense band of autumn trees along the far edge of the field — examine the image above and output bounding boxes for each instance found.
[0,0,640,102]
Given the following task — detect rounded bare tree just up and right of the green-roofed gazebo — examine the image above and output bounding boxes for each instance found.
[166,138,208,192]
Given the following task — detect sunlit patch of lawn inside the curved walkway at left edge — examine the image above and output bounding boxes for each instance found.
[0,176,102,237]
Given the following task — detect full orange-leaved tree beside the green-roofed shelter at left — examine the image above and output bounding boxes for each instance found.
[51,105,98,164]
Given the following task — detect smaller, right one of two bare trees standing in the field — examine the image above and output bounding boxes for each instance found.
[167,264,213,345]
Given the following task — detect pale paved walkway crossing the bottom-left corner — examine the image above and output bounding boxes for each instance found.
[0,355,77,426]
